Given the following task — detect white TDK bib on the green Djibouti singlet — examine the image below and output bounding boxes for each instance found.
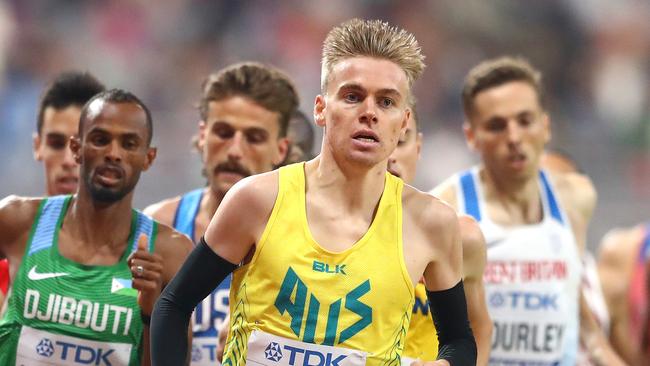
[16,326,132,366]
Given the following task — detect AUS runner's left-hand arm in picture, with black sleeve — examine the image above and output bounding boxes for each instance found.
[151,172,278,365]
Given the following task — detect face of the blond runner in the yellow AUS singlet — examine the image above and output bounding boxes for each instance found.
[314,57,410,166]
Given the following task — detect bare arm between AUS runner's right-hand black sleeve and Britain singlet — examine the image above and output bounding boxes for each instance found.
[459,215,492,366]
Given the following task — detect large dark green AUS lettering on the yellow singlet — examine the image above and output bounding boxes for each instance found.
[275,267,372,346]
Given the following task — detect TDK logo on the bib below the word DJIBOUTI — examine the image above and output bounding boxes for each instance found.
[36,338,115,366]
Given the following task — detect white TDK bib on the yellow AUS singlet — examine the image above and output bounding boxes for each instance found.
[246,330,367,366]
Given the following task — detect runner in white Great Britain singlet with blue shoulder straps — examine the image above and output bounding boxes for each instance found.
[433,57,620,366]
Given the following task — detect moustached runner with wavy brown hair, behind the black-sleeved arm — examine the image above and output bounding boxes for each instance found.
[144,62,299,366]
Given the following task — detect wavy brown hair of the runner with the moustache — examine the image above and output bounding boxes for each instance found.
[199,62,299,137]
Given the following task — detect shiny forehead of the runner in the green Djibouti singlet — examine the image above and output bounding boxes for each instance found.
[82,100,147,137]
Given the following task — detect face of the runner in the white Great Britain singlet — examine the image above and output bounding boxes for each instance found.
[465,81,550,180]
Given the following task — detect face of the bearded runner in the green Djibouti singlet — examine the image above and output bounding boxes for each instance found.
[72,100,156,203]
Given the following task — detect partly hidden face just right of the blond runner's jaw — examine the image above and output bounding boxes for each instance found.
[388,114,422,184]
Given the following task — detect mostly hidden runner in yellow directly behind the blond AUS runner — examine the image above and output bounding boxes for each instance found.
[388,98,492,366]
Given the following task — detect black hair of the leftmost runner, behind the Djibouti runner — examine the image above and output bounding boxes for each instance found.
[36,71,106,135]
